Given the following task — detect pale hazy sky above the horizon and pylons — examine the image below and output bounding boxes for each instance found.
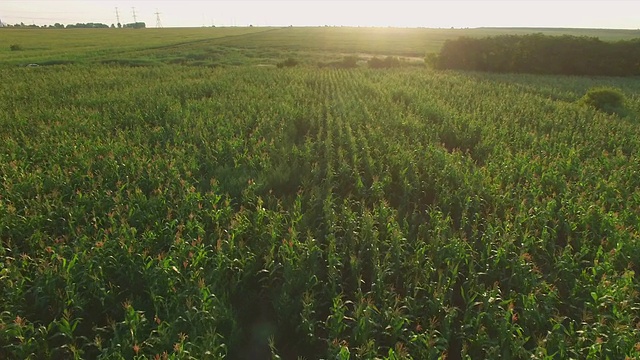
[0,0,640,29]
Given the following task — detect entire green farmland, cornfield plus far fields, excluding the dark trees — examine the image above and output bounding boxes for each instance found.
[0,28,640,359]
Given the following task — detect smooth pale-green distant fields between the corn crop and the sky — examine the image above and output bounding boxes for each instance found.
[0,27,640,65]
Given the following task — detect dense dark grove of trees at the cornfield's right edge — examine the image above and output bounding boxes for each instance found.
[427,34,640,76]
